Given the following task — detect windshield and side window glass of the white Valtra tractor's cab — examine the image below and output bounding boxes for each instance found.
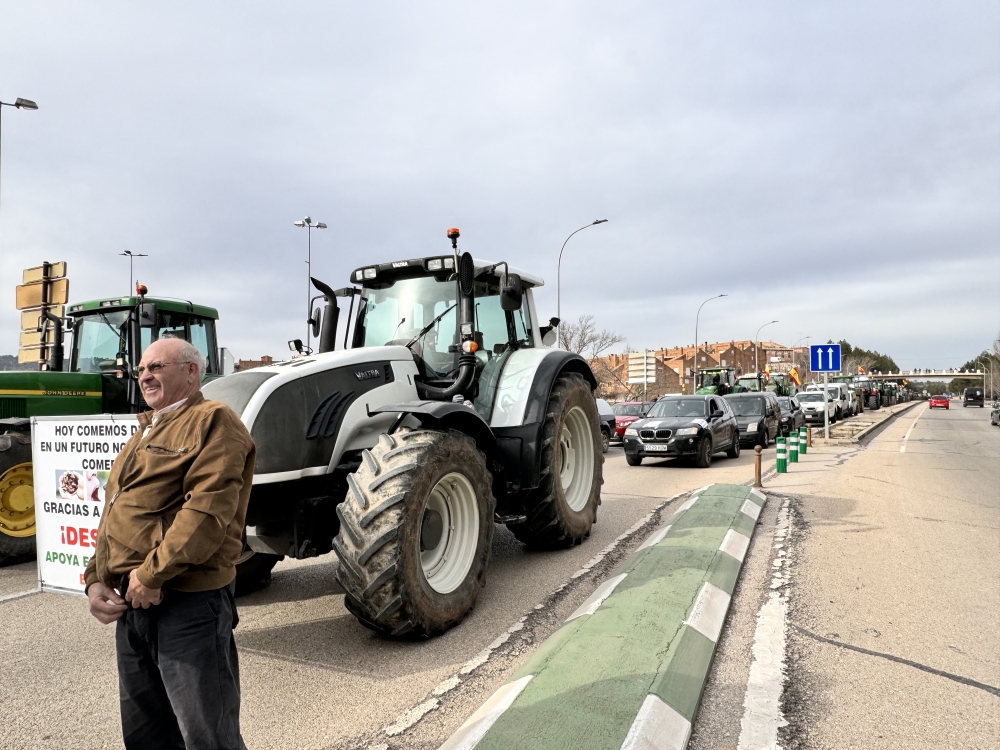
[354,276,531,378]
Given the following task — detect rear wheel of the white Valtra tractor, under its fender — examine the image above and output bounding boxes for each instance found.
[509,373,600,549]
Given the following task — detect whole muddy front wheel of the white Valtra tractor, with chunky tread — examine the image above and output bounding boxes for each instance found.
[333,429,496,639]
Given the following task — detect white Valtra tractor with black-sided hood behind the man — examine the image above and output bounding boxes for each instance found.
[204,229,604,638]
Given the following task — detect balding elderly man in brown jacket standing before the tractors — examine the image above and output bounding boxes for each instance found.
[85,339,254,750]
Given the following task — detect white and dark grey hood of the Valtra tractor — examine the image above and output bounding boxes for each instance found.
[202,346,417,484]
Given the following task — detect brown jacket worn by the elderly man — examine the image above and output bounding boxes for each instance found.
[84,392,255,591]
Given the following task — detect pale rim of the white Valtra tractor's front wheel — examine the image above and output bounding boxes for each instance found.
[417,472,480,594]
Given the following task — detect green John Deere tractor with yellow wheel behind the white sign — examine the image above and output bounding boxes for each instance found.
[0,296,222,563]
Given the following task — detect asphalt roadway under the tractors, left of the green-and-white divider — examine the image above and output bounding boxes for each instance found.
[0,432,774,749]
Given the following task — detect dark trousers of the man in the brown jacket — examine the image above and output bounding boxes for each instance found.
[115,584,246,750]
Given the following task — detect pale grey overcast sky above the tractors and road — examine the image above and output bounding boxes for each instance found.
[0,0,1000,368]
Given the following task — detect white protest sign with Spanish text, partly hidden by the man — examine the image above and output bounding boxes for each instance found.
[31,414,139,594]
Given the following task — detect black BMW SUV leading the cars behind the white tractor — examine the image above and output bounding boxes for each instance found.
[624,395,740,469]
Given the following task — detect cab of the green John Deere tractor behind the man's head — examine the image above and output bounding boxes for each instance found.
[67,297,221,413]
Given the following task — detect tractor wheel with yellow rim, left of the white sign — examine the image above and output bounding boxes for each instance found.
[0,432,35,563]
